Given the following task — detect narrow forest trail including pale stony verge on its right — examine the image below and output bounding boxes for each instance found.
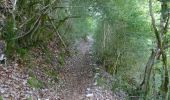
[57,36,122,100]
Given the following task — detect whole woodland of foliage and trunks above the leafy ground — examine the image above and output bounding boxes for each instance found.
[0,0,170,100]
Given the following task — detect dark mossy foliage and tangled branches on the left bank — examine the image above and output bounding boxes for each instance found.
[1,0,68,56]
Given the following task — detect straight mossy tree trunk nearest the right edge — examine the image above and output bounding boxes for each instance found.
[160,1,169,100]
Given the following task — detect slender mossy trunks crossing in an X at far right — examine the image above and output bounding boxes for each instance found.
[141,0,169,100]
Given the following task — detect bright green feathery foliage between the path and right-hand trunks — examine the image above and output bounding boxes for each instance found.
[67,0,156,97]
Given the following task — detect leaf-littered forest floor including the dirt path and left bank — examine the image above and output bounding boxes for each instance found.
[0,36,126,100]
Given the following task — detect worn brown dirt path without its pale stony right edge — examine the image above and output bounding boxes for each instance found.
[60,41,93,100]
